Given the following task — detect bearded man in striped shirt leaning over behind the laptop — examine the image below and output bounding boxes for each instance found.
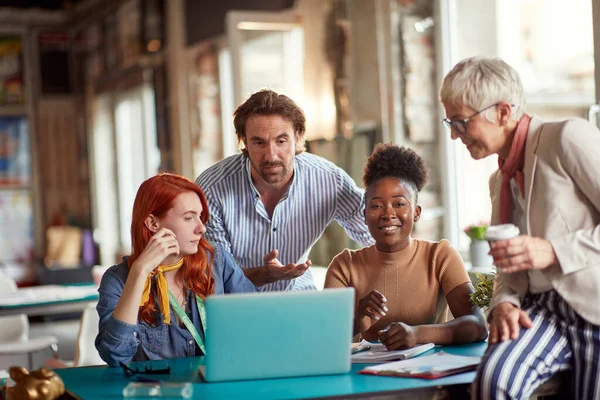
[196,90,373,291]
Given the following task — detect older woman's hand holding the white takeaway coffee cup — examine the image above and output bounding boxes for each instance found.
[489,235,558,273]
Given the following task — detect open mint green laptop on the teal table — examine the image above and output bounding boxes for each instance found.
[200,288,354,382]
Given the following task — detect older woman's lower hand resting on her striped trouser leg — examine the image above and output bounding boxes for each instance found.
[488,302,533,344]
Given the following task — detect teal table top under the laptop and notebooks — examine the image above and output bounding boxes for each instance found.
[56,342,487,400]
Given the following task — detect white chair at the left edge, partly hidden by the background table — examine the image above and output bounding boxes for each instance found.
[0,273,58,369]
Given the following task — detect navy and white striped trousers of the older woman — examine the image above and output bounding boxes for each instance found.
[473,290,600,399]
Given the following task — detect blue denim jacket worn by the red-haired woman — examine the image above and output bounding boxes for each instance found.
[96,245,256,366]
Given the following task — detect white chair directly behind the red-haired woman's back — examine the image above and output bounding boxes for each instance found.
[45,304,106,368]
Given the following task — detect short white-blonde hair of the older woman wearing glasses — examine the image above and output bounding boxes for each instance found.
[440,57,525,122]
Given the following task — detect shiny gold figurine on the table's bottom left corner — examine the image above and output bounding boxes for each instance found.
[6,367,65,400]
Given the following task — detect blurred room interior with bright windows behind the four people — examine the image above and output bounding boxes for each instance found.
[0,0,600,369]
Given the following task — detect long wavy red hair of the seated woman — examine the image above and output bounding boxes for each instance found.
[128,173,215,323]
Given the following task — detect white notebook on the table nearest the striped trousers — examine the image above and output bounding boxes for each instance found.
[358,351,481,379]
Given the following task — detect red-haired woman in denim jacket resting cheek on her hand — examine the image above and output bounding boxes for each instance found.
[96,174,258,366]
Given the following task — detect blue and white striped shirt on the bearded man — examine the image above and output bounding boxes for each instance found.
[196,153,374,291]
